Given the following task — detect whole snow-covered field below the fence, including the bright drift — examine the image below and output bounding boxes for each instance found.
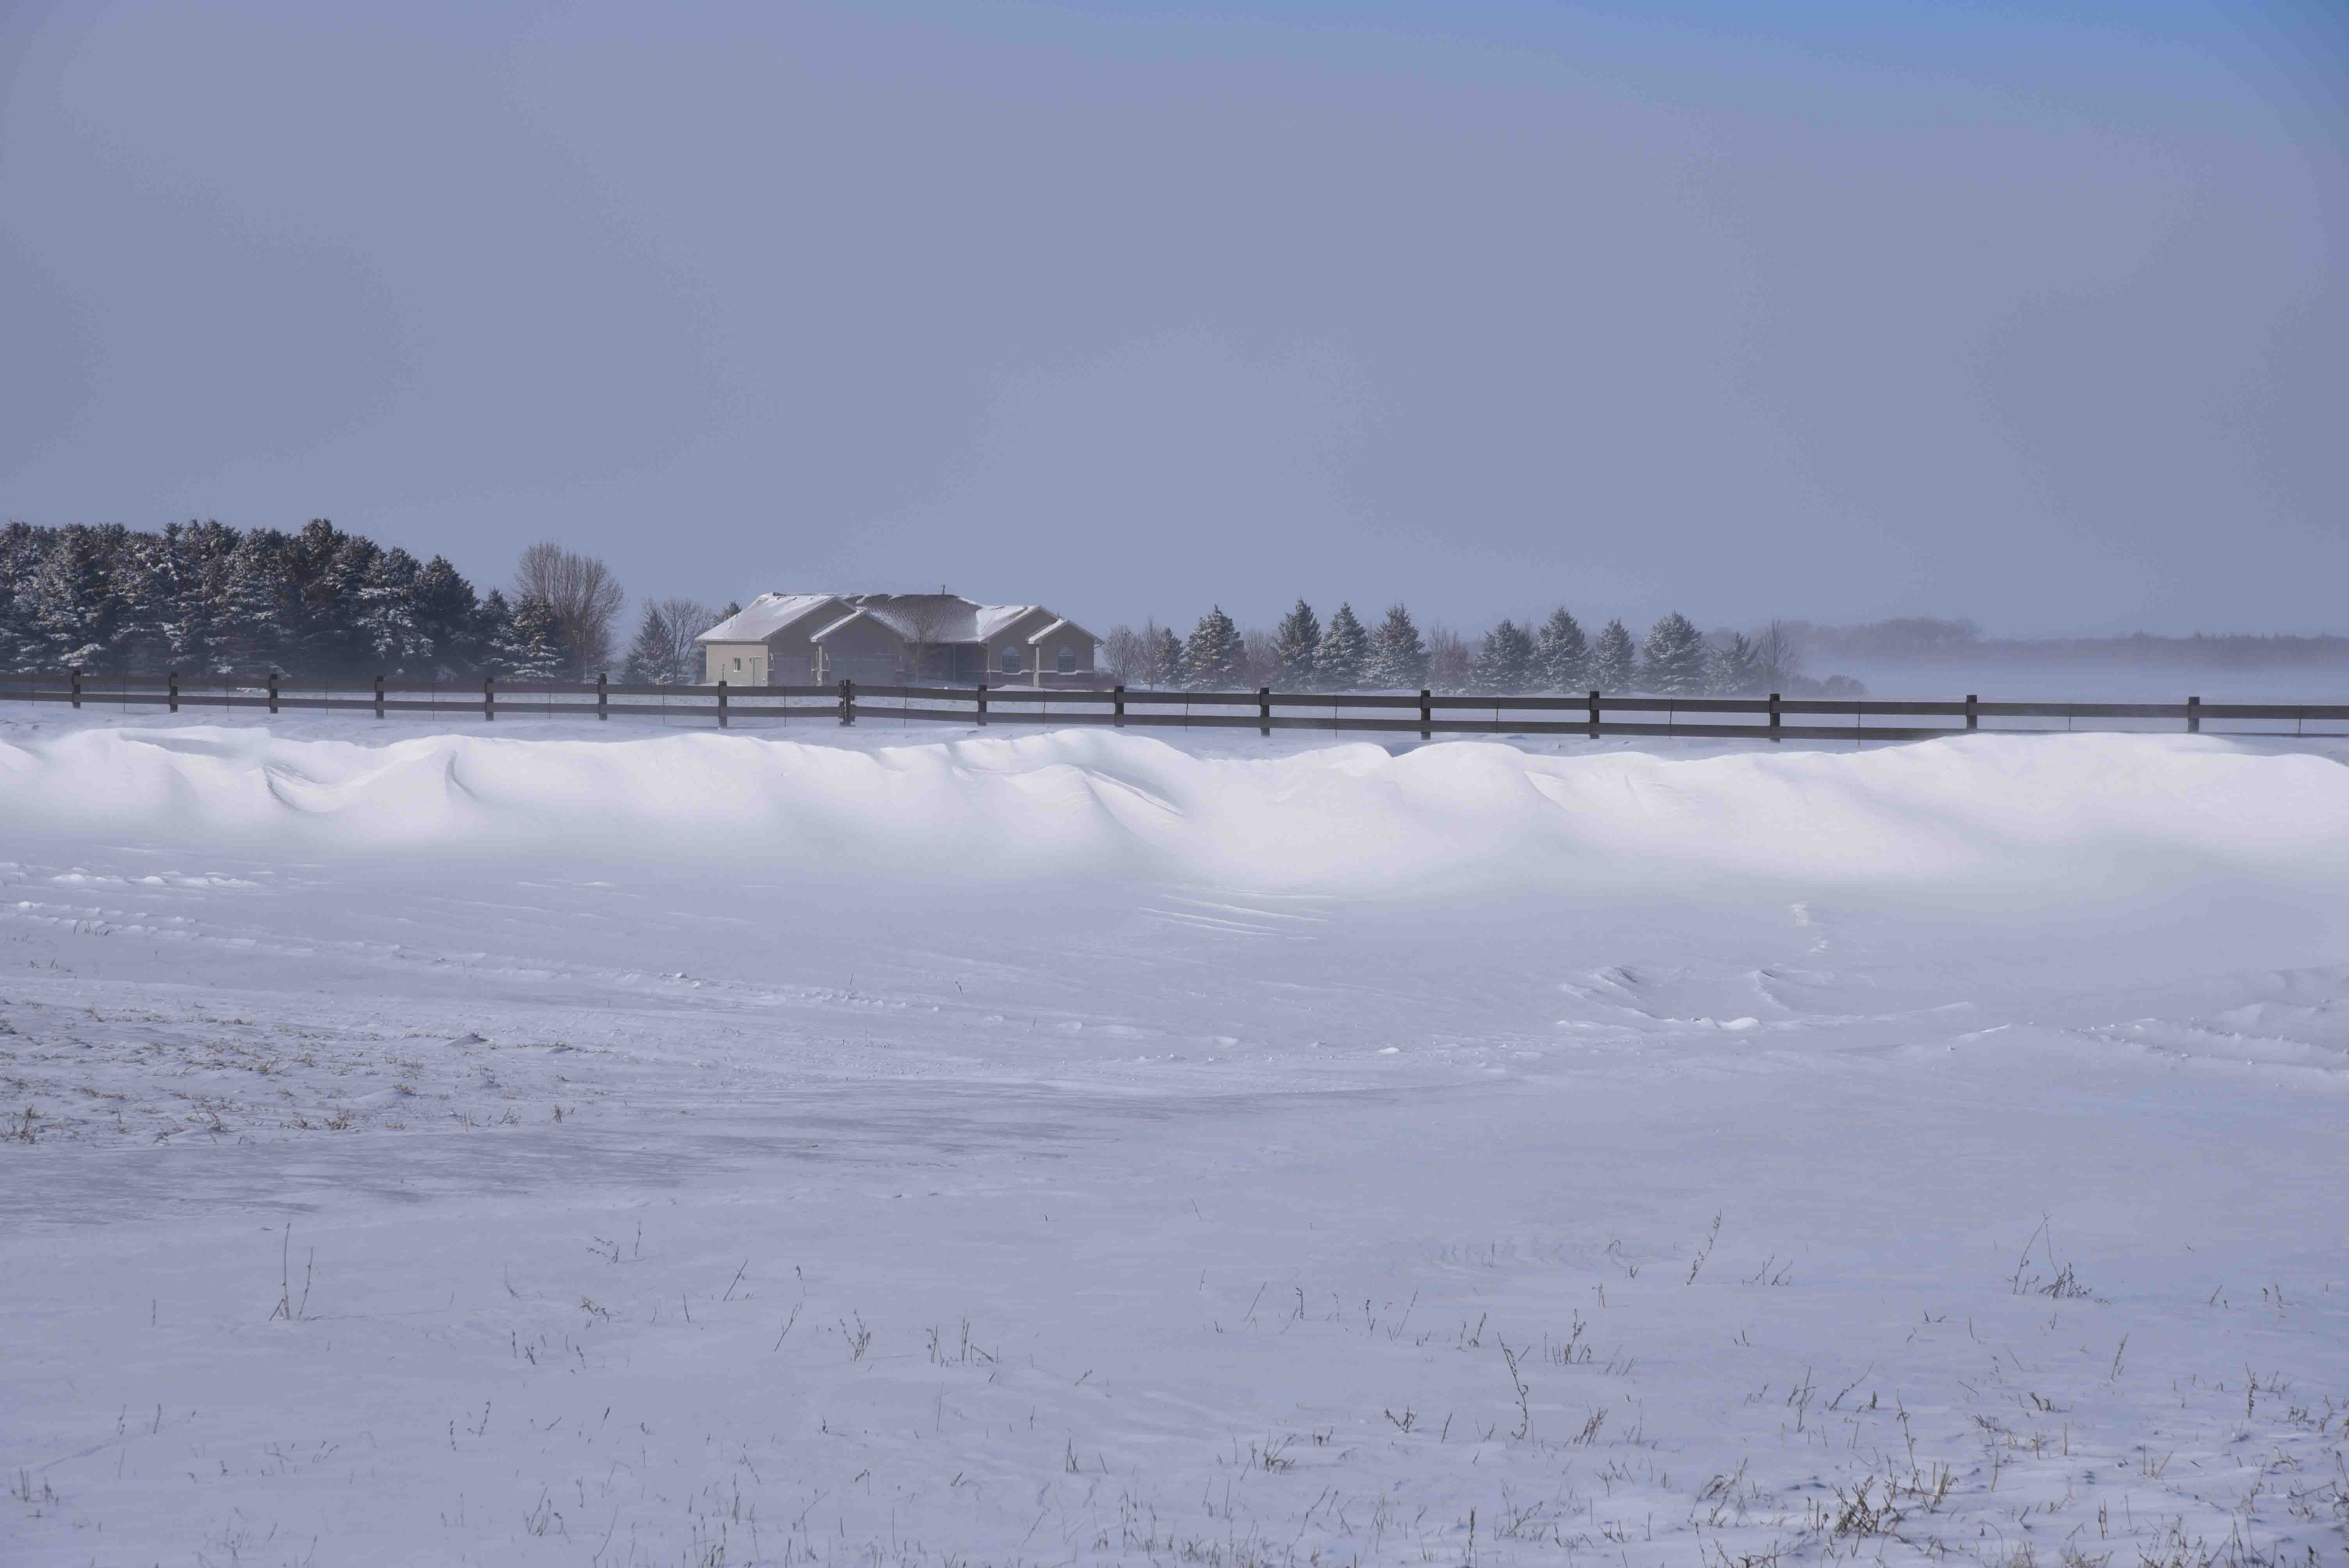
[0,709,2349,1568]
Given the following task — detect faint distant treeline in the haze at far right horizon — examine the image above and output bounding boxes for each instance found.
[1785,615,2349,669]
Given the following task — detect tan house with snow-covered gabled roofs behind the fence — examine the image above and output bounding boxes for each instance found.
[695,594,1099,685]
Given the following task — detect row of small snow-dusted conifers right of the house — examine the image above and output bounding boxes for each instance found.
[1102,599,1846,697]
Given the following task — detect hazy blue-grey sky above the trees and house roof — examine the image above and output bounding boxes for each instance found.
[0,0,2349,634]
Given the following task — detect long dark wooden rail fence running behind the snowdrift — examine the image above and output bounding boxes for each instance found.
[0,671,2349,742]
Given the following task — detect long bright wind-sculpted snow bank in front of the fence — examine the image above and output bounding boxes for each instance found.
[0,728,2349,894]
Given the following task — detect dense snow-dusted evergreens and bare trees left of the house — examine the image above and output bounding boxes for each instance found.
[0,519,719,683]
